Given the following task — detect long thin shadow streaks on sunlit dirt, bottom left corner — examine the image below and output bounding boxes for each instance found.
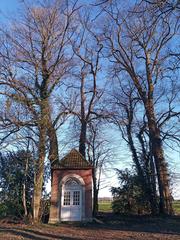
[0,226,79,240]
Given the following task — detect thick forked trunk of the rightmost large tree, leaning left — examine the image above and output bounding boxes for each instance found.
[128,52,173,214]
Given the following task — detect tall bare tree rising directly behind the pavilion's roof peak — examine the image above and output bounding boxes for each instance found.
[68,11,103,157]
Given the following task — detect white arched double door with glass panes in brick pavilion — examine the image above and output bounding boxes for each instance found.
[61,178,82,221]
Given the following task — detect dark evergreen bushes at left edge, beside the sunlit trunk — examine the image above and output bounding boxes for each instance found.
[0,151,34,218]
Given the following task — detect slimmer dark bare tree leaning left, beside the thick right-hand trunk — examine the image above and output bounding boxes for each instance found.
[109,76,158,214]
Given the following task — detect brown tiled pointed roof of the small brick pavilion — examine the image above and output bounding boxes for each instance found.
[53,149,92,169]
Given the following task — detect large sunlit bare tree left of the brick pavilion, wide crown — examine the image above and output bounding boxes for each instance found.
[0,1,77,221]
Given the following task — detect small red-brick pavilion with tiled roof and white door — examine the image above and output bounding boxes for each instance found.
[49,149,92,223]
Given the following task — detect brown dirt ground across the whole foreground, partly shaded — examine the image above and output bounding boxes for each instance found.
[0,214,180,240]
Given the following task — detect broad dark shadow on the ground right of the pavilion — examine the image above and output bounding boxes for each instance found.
[76,213,180,235]
